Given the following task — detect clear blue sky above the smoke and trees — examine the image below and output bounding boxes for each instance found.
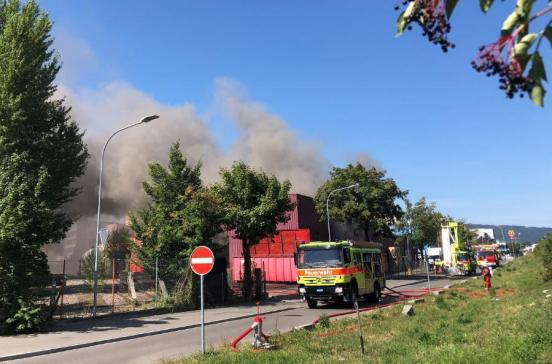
[40,0,552,226]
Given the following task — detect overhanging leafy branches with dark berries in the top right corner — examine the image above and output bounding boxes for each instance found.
[395,0,552,106]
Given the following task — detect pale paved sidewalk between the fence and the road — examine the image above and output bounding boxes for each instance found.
[0,302,301,361]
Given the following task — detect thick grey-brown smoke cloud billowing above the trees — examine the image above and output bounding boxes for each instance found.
[58,78,338,217]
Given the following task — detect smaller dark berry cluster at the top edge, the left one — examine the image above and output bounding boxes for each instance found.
[395,0,455,53]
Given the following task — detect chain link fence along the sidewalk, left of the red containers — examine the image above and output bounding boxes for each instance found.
[47,255,230,319]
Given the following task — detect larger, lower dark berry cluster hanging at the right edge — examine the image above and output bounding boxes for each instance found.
[471,39,534,98]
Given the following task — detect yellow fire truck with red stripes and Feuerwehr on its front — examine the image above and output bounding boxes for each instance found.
[296,241,385,308]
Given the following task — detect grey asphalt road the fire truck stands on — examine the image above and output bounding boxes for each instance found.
[12,278,462,364]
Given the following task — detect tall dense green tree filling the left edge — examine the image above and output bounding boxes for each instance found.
[0,0,88,333]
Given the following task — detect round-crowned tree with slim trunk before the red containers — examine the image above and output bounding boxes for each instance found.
[214,162,294,299]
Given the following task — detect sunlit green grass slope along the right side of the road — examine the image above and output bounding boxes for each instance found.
[170,256,552,364]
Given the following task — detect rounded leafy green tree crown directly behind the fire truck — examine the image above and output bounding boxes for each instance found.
[314,163,407,240]
